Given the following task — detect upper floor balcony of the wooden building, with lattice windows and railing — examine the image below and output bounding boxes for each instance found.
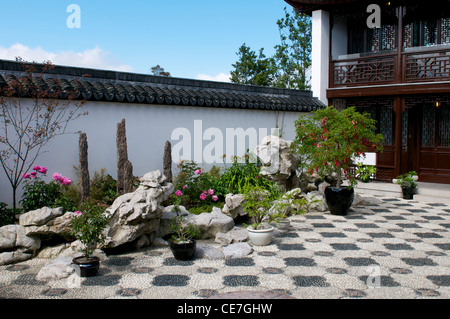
[329,4,450,90]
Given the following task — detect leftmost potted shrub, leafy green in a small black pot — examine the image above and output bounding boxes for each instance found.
[72,202,109,277]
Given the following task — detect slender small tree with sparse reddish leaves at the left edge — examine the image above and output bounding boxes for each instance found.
[0,58,87,211]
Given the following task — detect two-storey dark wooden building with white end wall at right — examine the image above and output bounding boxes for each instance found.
[286,0,450,184]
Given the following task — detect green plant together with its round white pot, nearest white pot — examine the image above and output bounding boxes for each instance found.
[243,186,280,246]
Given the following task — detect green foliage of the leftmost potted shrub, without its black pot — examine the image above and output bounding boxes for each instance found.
[72,201,109,257]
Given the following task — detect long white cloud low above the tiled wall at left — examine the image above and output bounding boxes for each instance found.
[0,43,133,72]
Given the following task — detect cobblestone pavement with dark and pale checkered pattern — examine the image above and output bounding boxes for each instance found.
[0,197,450,299]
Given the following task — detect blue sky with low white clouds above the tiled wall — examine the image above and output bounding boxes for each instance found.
[0,0,291,80]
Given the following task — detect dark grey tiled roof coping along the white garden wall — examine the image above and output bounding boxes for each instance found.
[0,60,325,112]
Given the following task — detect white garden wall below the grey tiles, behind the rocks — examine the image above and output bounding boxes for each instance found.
[0,101,308,210]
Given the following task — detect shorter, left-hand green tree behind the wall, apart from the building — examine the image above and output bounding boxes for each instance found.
[230,43,276,86]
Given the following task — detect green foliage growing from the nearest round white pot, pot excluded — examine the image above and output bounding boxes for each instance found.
[243,186,281,230]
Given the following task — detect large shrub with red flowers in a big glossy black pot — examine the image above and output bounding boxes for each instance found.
[291,106,383,215]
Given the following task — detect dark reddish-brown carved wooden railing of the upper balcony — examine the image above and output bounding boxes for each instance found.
[330,46,450,88]
